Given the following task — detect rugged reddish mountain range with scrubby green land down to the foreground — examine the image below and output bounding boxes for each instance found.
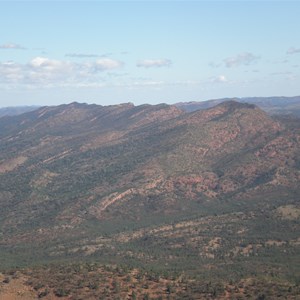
[0,101,300,299]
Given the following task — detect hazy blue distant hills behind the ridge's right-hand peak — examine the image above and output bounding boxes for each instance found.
[175,96,300,117]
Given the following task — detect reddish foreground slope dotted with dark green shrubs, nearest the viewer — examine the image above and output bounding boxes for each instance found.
[0,263,300,299]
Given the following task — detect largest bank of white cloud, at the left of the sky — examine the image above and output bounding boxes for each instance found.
[0,57,123,88]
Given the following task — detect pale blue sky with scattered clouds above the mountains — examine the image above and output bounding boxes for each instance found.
[0,0,300,107]
